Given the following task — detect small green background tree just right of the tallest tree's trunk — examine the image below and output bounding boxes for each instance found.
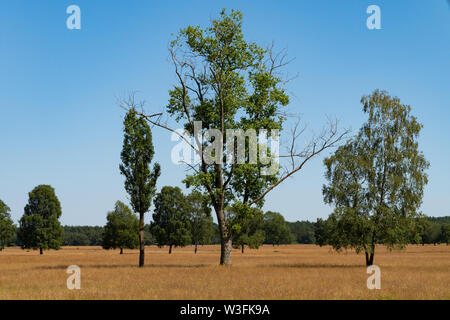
[228,204,266,253]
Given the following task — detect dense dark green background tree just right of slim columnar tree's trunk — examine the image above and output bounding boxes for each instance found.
[152,186,191,254]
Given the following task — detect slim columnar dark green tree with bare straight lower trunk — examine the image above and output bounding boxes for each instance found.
[120,109,161,267]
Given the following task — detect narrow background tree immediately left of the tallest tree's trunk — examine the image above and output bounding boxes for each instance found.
[186,191,213,253]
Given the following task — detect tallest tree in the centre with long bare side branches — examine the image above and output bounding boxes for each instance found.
[124,10,345,265]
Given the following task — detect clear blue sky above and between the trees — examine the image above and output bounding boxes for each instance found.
[0,0,450,225]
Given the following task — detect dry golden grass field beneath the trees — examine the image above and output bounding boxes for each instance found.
[0,245,450,299]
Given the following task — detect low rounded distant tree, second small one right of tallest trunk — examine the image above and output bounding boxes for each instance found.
[264,211,292,246]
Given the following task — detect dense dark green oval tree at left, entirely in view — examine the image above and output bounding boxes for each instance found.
[18,185,63,254]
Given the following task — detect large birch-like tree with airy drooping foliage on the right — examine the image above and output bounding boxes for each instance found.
[323,90,429,265]
